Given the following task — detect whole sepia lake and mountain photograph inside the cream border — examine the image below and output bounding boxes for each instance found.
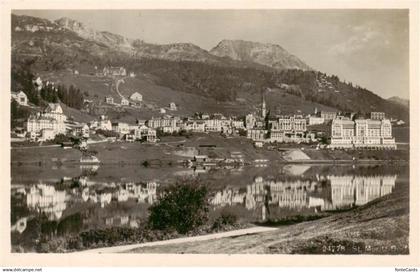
[2,1,418,266]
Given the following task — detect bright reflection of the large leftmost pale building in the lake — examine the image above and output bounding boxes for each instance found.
[26,184,66,220]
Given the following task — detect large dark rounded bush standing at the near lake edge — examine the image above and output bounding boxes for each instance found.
[148,182,209,234]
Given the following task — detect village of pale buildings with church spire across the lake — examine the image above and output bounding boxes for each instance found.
[12,67,403,159]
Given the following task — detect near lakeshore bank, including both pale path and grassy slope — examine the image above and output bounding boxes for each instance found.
[65,180,409,254]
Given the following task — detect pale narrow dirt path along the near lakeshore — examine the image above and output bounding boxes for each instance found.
[74,227,277,254]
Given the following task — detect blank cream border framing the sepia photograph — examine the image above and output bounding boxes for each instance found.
[0,0,420,267]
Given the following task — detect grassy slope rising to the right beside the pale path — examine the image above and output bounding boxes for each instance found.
[127,182,409,254]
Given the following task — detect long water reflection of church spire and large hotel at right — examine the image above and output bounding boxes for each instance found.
[210,175,397,217]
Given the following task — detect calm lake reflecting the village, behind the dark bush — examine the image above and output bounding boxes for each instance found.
[11,164,409,251]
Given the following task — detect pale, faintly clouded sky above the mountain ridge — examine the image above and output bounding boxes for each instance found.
[13,9,409,99]
